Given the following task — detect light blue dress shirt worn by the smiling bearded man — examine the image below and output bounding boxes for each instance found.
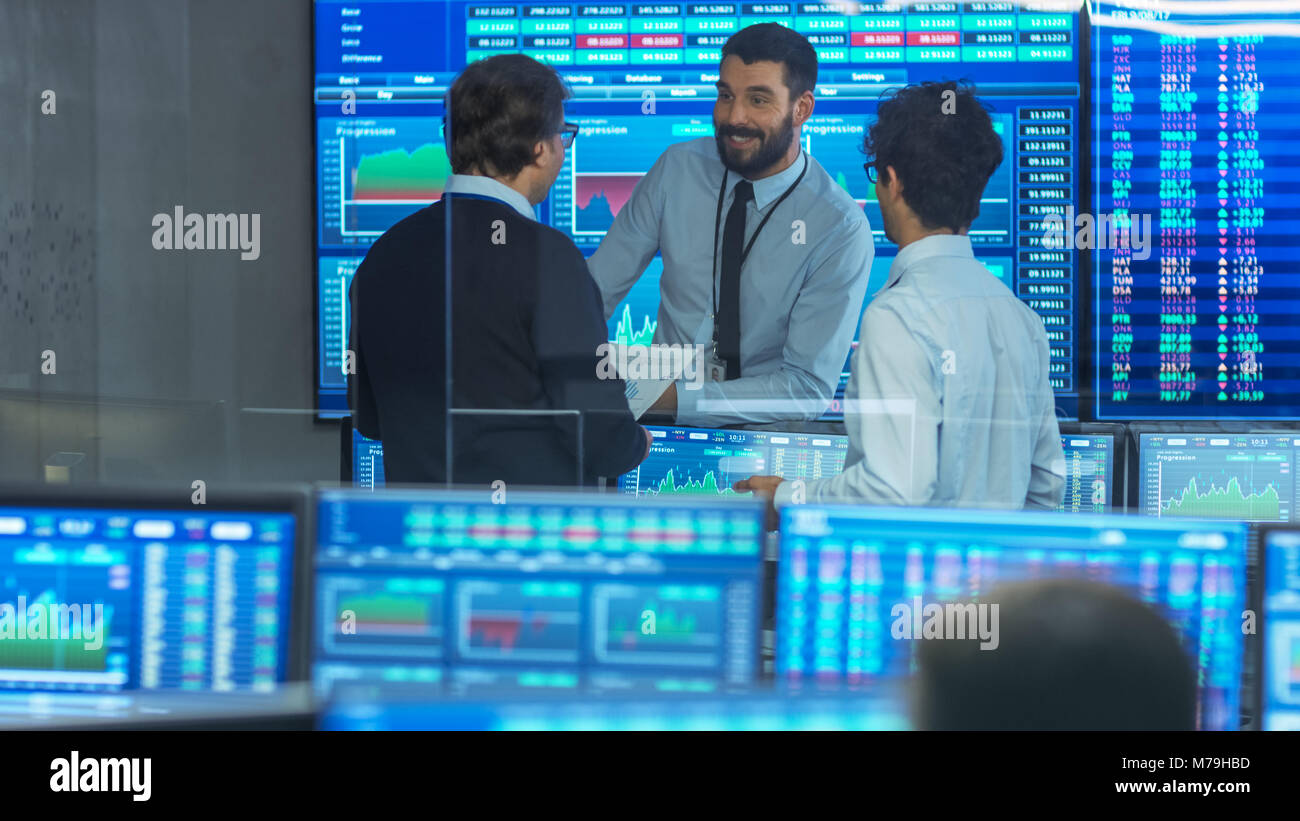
[588,136,875,427]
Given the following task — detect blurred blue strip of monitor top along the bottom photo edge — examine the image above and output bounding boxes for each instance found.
[321,688,910,731]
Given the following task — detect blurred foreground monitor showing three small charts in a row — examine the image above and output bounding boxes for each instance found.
[313,488,763,695]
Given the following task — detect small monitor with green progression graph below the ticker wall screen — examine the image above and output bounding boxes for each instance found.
[1138,433,1300,522]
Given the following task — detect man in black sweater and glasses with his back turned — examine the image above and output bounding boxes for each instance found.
[347,55,650,486]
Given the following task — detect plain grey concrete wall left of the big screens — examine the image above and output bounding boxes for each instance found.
[0,0,338,481]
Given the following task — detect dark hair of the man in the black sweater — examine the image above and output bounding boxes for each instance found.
[445,55,569,178]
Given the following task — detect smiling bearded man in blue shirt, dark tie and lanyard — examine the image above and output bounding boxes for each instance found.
[588,23,875,427]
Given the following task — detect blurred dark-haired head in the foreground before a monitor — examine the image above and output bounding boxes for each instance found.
[915,579,1196,730]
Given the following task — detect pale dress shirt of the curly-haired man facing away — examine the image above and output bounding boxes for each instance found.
[775,234,1065,509]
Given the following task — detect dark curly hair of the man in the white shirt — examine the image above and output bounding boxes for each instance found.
[862,81,1002,231]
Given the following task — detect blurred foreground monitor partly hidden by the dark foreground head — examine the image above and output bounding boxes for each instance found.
[776,505,1245,729]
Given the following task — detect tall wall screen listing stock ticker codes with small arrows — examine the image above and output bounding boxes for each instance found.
[1092,3,1300,420]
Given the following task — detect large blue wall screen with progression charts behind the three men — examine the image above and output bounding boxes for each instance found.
[315,0,1080,418]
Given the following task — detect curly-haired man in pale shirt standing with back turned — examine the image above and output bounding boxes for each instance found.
[736,82,1065,509]
